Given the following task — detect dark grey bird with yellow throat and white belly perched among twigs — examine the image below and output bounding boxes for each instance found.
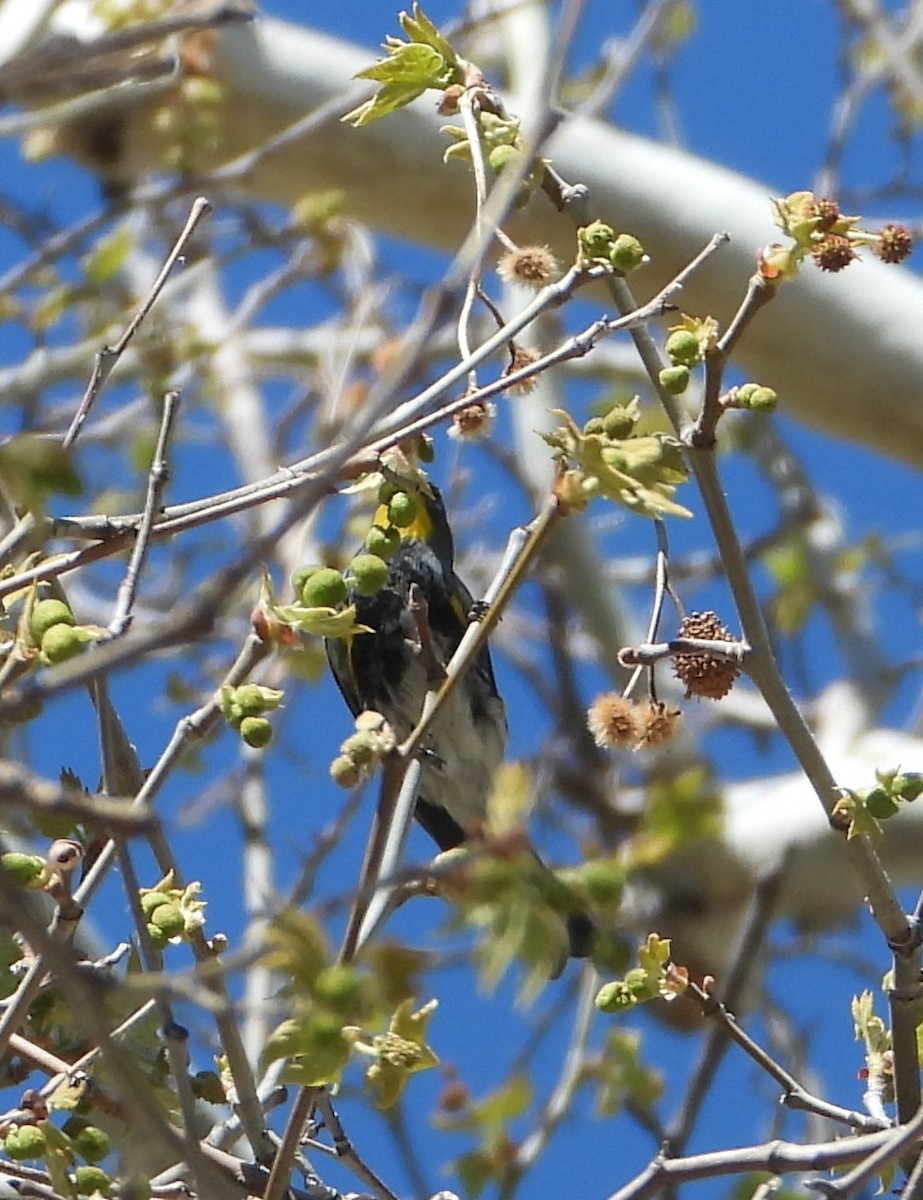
[326,484,594,956]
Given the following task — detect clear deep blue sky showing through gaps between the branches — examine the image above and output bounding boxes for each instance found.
[0,0,923,1198]
